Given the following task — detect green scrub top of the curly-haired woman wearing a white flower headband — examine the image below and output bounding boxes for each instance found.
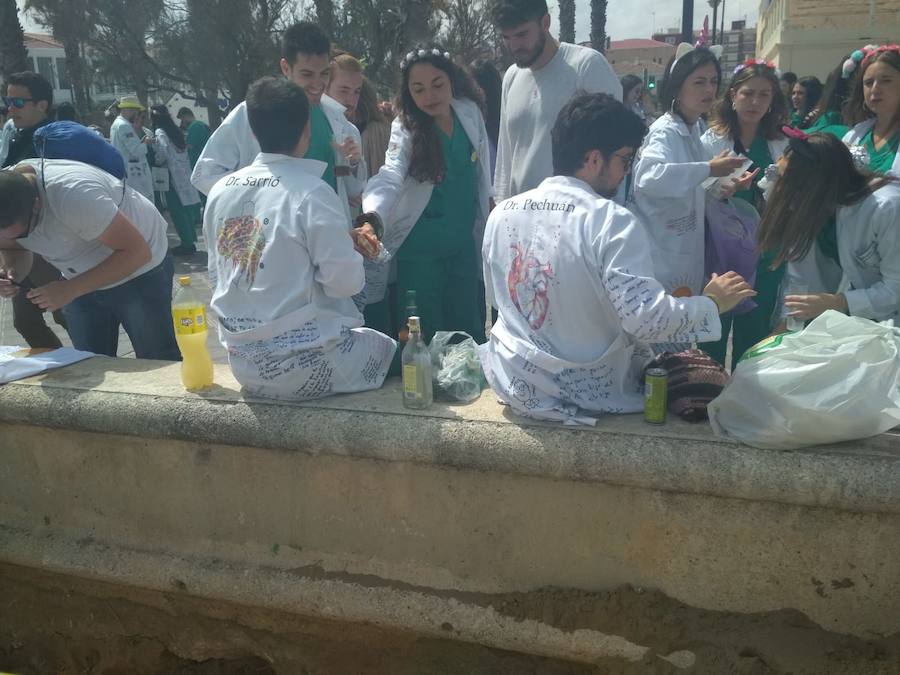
[397,113,478,259]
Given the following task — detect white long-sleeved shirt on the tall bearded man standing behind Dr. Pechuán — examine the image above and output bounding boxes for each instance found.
[494,42,622,202]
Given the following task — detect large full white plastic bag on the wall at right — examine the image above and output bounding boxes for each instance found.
[708,311,900,450]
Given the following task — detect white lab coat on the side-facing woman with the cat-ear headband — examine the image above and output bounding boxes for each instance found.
[629,113,711,295]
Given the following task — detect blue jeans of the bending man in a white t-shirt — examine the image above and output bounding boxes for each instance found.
[63,254,181,361]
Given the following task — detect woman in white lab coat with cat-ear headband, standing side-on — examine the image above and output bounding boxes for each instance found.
[629,43,742,296]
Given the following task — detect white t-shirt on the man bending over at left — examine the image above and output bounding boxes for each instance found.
[18,159,169,288]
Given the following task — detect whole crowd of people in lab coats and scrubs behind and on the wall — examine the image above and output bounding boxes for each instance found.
[0,0,900,422]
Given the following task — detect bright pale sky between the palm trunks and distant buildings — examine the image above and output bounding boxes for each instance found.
[16,0,759,42]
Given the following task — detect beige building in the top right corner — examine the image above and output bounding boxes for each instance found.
[756,0,900,80]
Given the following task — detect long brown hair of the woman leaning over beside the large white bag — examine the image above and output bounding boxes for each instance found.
[759,133,895,266]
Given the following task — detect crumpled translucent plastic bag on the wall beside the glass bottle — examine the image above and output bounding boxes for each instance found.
[428,331,487,401]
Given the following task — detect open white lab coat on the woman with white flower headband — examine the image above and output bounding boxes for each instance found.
[358,99,493,305]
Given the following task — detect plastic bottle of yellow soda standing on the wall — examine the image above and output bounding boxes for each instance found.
[172,276,213,391]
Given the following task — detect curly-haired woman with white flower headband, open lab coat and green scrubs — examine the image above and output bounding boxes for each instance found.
[360,48,493,342]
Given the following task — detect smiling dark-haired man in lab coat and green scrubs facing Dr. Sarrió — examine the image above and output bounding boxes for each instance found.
[191,21,367,226]
